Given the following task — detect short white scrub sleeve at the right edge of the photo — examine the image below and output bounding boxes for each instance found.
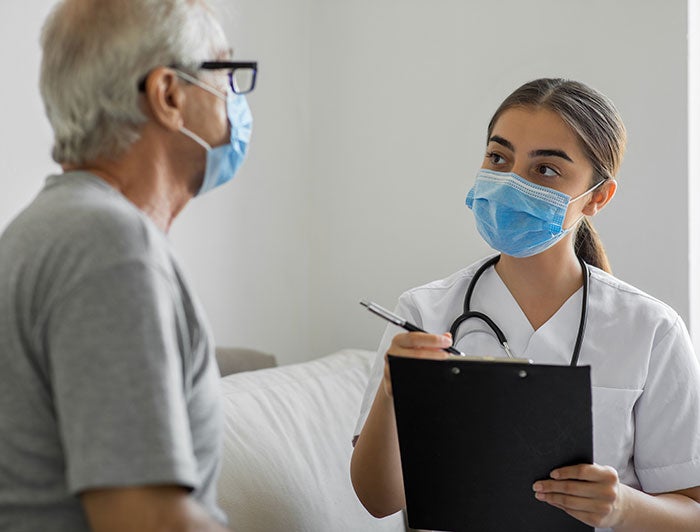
[634,318,700,493]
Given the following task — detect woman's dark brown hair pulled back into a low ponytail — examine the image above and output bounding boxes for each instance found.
[486,78,627,272]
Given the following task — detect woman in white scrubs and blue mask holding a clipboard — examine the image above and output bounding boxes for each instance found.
[351,79,700,532]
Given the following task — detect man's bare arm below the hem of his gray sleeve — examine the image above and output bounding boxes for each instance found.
[80,486,228,532]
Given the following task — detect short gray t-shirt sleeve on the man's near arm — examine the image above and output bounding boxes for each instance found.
[44,260,198,493]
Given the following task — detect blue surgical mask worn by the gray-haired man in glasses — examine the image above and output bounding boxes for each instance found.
[178,77,253,196]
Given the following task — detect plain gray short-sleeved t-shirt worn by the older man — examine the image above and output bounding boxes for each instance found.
[0,172,225,532]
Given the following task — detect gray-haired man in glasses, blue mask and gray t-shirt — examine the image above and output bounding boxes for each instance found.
[0,0,256,532]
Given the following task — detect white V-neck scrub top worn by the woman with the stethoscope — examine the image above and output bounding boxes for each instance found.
[355,259,700,520]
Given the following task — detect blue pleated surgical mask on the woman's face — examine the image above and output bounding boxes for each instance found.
[467,168,604,257]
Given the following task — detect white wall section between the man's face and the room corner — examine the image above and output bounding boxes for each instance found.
[171,0,311,362]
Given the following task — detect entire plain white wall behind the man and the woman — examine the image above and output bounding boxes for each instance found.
[0,0,689,362]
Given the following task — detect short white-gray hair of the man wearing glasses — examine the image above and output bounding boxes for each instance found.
[40,0,228,164]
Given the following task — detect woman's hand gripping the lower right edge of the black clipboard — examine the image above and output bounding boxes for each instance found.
[532,464,627,528]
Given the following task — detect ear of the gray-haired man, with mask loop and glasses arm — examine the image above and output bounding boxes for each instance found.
[144,67,186,131]
